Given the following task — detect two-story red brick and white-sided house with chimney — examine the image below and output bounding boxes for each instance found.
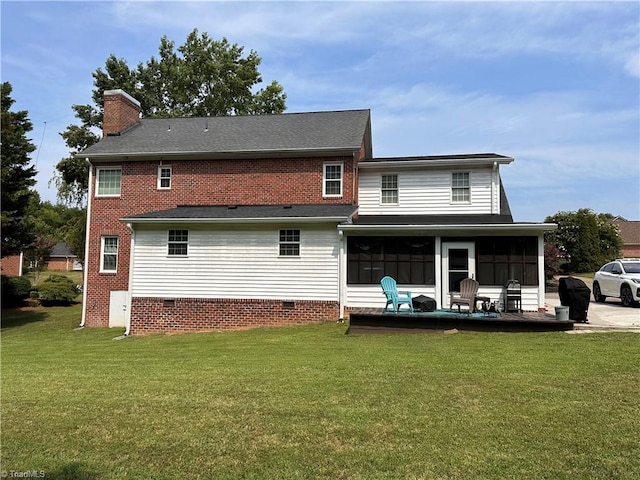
[80,90,555,334]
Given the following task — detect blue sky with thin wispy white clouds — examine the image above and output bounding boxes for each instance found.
[0,0,640,221]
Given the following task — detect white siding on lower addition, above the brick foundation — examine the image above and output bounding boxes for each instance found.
[131,225,340,301]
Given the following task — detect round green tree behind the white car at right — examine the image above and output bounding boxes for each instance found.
[545,208,622,272]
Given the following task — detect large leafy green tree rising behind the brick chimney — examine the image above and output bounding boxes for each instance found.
[54,30,287,205]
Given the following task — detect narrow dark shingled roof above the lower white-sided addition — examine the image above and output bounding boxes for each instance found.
[122,204,358,222]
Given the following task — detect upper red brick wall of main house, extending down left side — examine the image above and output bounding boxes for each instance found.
[85,153,357,327]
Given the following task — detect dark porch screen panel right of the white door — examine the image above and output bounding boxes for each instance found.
[477,237,538,286]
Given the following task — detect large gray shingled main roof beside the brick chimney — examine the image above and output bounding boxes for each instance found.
[77,110,371,161]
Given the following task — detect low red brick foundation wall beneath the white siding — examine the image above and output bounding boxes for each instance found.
[131,297,340,335]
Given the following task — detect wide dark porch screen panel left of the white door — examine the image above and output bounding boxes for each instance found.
[347,237,435,285]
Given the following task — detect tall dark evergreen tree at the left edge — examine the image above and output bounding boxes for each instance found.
[0,82,37,256]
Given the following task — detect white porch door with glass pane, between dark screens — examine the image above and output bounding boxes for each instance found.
[442,242,476,308]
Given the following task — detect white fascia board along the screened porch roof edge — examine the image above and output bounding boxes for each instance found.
[338,223,558,235]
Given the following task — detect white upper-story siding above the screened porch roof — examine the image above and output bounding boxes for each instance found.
[358,168,492,215]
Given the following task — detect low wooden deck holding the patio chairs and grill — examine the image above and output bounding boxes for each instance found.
[349,308,574,333]
